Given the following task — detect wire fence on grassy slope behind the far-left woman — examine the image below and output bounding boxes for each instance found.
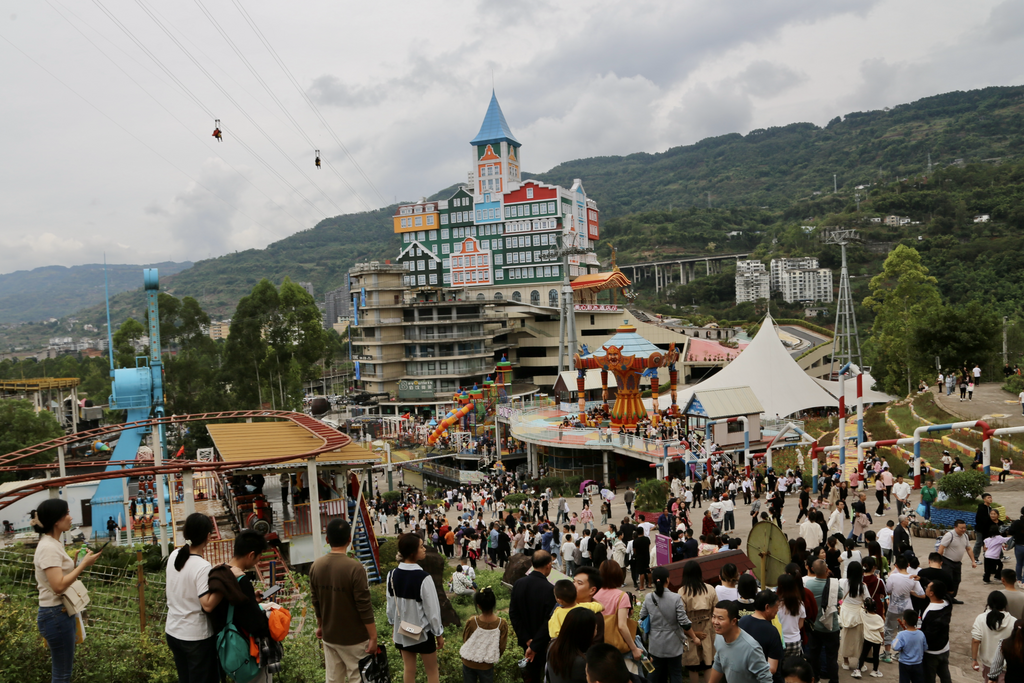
[0,550,167,635]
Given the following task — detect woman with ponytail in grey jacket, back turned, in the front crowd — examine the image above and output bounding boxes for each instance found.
[640,566,700,683]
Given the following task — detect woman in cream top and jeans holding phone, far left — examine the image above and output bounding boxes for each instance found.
[32,498,99,683]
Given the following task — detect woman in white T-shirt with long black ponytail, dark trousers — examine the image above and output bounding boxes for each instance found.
[164,512,220,683]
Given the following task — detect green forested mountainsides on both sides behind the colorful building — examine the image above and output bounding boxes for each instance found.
[8,86,1024,339]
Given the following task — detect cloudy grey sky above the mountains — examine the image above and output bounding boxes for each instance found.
[0,0,1024,272]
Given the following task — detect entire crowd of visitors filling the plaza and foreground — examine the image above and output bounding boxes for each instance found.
[25,440,1024,683]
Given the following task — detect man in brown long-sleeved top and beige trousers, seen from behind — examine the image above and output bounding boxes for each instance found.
[309,519,377,683]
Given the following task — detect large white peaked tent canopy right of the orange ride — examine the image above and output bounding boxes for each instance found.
[644,315,839,418]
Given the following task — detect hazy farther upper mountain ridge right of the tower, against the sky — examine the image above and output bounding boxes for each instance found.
[531,86,1024,218]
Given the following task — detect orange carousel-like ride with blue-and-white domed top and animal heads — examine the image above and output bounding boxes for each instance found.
[572,325,679,428]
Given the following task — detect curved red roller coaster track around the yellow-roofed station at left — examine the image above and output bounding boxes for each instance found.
[0,411,351,510]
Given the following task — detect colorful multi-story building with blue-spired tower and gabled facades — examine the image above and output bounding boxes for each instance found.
[393,93,600,307]
